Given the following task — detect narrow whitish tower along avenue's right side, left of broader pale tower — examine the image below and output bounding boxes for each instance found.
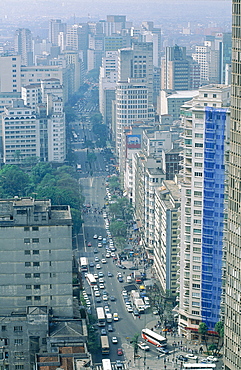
[99,51,118,133]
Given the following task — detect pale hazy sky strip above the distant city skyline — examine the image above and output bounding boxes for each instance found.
[0,0,231,22]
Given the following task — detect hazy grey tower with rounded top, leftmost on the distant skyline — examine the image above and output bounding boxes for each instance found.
[14,28,33,66]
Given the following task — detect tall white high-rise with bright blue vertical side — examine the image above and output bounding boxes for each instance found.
[179,85,230,339]
